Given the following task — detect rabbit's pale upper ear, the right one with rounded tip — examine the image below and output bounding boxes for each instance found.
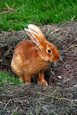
[28,24,46,40]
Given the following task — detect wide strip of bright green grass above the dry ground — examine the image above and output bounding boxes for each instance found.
[0,0,77,30]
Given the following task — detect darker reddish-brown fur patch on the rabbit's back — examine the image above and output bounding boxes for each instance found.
[14,40,37,61]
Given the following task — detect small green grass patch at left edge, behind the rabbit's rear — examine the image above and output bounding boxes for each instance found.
[0,71,20,85]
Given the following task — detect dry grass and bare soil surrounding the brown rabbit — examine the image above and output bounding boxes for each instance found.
[0,20,77,115]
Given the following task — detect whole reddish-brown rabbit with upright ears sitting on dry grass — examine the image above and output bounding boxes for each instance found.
[11,24,59,85]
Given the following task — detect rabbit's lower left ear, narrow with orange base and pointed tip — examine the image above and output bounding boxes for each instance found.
[25,28,42,48]
